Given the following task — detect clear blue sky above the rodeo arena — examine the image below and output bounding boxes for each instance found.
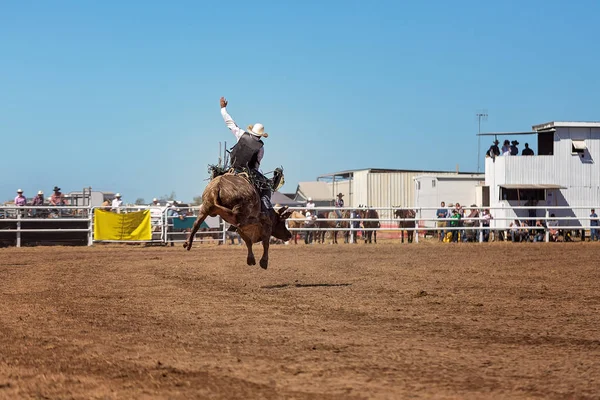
[0,0,600,202]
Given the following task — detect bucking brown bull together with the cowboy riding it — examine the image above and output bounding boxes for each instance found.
[183,97,292,269]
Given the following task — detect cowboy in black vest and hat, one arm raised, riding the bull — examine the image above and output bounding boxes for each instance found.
[220,97,273,213]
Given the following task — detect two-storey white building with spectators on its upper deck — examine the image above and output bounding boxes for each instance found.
[484,122,600,227]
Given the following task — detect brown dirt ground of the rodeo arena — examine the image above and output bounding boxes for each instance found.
[0,243,600,399]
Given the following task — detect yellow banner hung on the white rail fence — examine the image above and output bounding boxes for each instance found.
[94,209,152,240]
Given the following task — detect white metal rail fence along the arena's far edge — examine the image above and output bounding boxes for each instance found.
[0,206,598,247]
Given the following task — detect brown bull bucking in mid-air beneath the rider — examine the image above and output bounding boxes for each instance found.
[183,174,292,269]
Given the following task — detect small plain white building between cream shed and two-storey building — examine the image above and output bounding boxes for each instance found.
[414,174,485,227]
